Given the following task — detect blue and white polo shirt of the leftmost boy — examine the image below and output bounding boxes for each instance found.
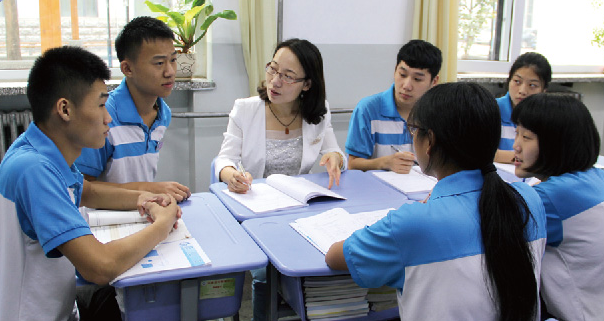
[0,123,91,321]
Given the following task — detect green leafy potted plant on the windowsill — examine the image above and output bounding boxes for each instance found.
[145,0,237,79]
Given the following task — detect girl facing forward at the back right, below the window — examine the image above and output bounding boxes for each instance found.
[495,52,552,164]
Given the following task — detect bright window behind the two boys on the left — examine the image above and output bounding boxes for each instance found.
[0,0,206,81]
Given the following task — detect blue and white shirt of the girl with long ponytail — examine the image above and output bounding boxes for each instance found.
[343,170,546,321]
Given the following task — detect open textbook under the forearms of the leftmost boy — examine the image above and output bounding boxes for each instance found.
[88,210,211,284]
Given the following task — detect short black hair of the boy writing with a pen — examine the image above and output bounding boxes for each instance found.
[396,39,443,79]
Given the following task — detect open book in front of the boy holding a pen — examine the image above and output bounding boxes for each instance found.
[372,166,437,196]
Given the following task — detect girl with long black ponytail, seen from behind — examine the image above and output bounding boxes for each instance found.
[325,83,546,321]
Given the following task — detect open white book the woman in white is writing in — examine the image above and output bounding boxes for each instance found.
[223,174,346,213]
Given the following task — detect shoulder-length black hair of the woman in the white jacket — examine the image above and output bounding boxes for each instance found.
[258,38,327,125]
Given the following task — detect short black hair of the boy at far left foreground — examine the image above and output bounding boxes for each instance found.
[27,46,111,124]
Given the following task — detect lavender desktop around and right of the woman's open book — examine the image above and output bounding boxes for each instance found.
[210,170,408,221]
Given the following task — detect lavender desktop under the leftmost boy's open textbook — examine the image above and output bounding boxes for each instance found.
[114,193,268,288]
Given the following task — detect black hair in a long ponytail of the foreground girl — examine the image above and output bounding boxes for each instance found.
[409,83,538,320]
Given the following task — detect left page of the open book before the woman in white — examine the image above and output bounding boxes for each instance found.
[222,183,306,213]
